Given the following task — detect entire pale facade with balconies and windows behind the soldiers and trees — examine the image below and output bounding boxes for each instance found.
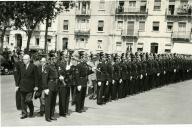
[1,0,192,54]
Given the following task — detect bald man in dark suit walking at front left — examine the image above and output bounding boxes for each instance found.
[16,54,38,119]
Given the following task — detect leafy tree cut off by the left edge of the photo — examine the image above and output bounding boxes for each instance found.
[0,1,15,53]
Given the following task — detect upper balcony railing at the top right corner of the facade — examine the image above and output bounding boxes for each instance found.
[166,7,192,16]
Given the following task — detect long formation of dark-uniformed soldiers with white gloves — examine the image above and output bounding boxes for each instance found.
[12,50,192,122]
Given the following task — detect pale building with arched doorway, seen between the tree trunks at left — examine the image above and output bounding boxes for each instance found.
[3,20,57,50]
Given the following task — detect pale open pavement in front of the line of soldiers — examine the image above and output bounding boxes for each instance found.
[1,76,192,126]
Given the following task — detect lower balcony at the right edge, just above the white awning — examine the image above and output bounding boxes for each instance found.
[171,31,191,41]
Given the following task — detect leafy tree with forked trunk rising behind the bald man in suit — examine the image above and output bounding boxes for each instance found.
[15,1,50,52]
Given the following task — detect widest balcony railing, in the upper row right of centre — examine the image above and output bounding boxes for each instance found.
[116,6,148,14]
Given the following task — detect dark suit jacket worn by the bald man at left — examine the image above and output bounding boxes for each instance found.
[18,63,38,92]
